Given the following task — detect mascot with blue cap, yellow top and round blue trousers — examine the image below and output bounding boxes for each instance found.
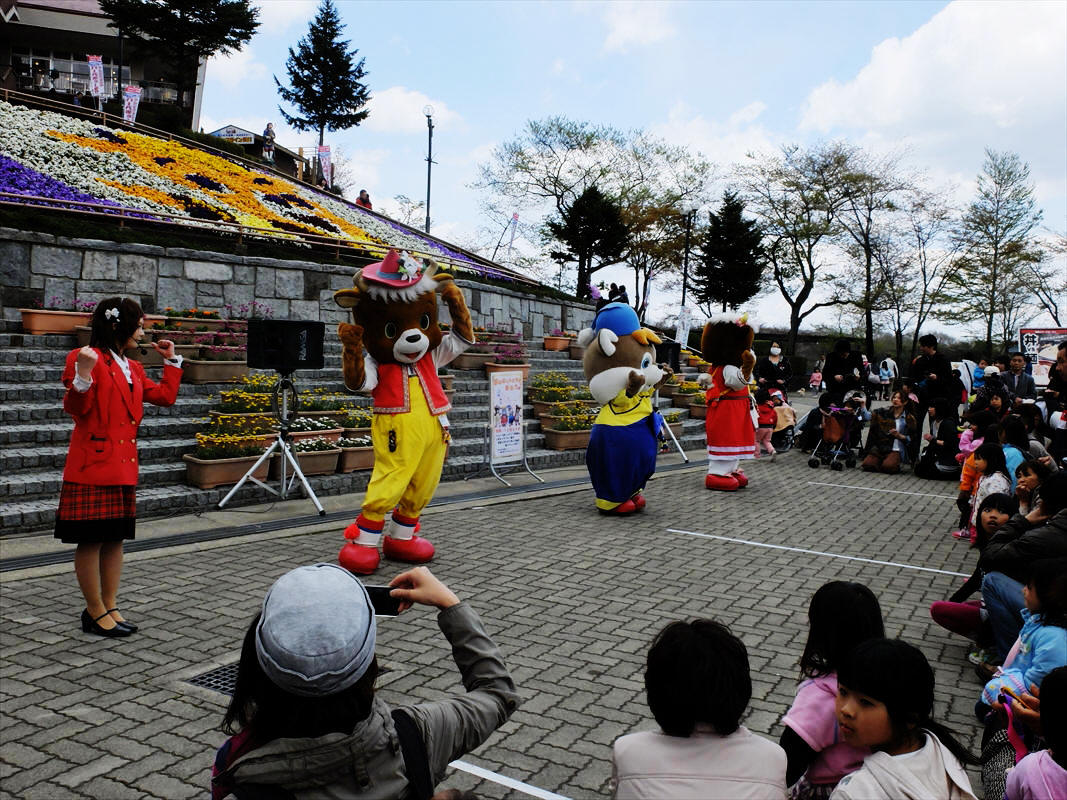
[578,303,673,514]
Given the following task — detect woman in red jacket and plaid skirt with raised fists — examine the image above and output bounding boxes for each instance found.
[55,298,181,637]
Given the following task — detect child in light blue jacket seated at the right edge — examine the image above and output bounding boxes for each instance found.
[975,558,1067,720]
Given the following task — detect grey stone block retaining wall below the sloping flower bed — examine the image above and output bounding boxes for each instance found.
[0,228,593,338]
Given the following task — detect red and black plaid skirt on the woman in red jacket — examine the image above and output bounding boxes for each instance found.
[55,481,137,544]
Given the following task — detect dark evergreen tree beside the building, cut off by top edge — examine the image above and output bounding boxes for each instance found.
[99,0,259,114]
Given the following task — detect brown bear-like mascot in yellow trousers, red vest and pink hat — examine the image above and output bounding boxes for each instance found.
[334,250,474,575]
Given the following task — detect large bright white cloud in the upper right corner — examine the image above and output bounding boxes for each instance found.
[800,2,1067,136]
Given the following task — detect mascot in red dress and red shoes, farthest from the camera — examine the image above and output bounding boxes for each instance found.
[700,315,757,492]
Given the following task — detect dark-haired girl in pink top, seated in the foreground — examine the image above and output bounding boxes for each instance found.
[779,580,886,800]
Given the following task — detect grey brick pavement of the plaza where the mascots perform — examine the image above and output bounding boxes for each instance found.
[0,451,994,800]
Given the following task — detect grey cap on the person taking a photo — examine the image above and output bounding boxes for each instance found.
[256,564,377,697]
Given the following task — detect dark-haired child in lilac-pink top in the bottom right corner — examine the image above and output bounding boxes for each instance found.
[1004,667,1067,800]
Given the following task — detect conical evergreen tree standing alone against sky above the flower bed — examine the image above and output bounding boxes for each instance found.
[274,0,370,161]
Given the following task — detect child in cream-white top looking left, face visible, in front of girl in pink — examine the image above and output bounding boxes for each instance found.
[830,639,980,800]
